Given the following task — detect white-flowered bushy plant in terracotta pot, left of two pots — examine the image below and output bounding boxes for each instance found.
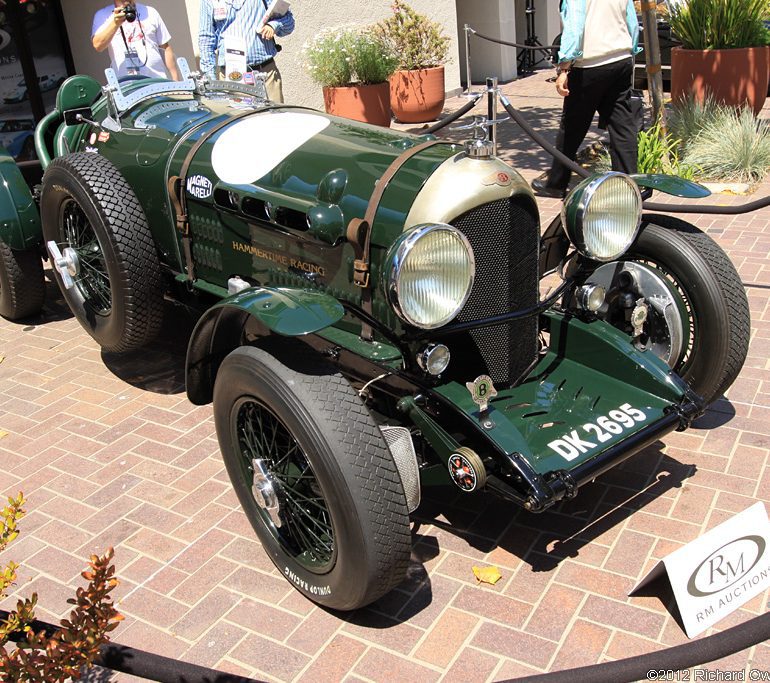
[304,28,398,126]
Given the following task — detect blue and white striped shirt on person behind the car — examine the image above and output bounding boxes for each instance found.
[198,0,294,78]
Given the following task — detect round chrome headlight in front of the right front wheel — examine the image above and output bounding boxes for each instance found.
[561,172,642,261]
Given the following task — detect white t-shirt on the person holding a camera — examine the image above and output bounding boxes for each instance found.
[91,3,171,78]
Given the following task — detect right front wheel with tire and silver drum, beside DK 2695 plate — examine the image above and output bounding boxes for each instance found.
[586,216,751,403]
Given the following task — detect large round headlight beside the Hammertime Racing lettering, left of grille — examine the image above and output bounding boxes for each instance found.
[385,223,476,329]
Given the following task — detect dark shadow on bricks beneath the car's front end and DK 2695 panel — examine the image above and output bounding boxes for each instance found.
[344,442,696,629]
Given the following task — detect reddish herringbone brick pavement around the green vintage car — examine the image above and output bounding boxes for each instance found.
[0,74,770,683]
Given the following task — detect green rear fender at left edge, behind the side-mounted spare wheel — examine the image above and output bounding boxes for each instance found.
[0,147,43,251]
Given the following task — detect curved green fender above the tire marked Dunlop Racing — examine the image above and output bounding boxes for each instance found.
[185,287,345,405]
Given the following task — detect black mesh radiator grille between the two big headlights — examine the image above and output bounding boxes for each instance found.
[442,197,539,386]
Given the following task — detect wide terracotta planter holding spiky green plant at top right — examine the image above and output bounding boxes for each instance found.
[671,46,770,114]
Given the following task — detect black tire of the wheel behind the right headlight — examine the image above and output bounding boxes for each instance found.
[588,216,751,403]
